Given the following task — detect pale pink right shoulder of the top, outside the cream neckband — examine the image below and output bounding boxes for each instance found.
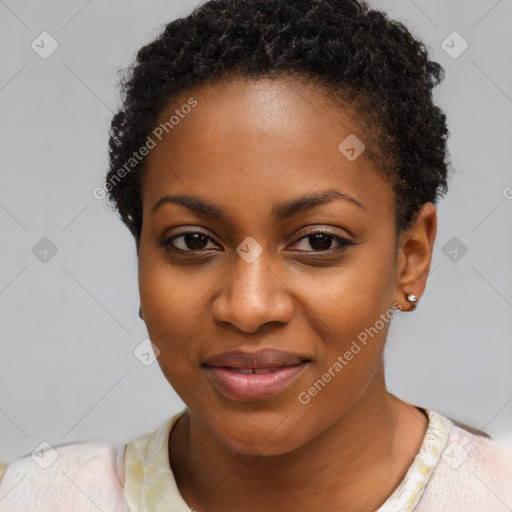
[416,422,512,512]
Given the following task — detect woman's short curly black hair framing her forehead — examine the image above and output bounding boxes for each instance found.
[105,0,449,243]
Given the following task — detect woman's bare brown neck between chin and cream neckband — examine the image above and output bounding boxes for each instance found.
[169,364,427,512]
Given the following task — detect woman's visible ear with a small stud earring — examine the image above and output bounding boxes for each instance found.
[395,203,437,311]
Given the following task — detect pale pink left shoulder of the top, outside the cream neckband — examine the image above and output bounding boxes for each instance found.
[0,441,128,512]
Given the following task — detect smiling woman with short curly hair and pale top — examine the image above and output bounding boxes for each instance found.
[0,0,512,512]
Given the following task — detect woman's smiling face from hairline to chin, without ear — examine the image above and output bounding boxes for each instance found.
[139,80,412,454]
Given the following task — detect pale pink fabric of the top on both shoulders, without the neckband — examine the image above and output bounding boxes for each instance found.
[0,418,512,512]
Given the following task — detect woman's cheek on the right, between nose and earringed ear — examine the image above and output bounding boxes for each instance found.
[303,241,395,400]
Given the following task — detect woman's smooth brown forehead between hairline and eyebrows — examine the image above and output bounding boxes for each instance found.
[142,79,393,224]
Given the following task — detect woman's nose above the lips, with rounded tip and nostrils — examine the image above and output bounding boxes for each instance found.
[211,250,293,333]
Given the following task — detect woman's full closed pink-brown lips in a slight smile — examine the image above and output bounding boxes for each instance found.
[202,349,311,400]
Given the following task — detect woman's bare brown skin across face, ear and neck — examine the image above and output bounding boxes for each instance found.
[139,79,437,512]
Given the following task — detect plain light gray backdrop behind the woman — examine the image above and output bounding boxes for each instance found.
[0,0,512,461]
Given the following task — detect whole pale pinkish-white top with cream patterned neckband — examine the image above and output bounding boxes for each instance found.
[0,409,512,512]
